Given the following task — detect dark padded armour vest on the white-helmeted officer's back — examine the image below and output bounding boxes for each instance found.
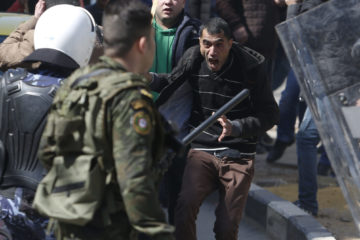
[0,68,58,190]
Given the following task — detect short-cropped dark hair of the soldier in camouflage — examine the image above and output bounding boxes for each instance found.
[103,0,152,57]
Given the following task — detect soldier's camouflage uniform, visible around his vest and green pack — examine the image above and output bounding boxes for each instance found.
[38,57,174,240]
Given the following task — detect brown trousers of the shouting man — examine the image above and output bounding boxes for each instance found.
[175,150,254,240]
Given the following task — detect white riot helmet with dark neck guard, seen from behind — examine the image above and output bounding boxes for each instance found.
[24,4,96,69]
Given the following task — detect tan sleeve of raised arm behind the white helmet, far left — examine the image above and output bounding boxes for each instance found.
[0,17,37,69]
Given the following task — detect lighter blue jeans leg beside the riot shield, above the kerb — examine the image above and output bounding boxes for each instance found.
[296,108,320,213]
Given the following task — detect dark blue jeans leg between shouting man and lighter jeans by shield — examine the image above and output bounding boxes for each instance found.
[277,70,305,143]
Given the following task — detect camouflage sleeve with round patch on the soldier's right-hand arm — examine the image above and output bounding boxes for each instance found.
[112,90,174,239]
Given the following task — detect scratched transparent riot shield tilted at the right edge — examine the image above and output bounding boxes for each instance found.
[276,0,360,231]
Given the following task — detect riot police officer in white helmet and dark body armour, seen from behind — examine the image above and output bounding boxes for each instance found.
[0,5,96,239]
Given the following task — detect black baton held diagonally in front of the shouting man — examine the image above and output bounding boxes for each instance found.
[182,89,249,146]
